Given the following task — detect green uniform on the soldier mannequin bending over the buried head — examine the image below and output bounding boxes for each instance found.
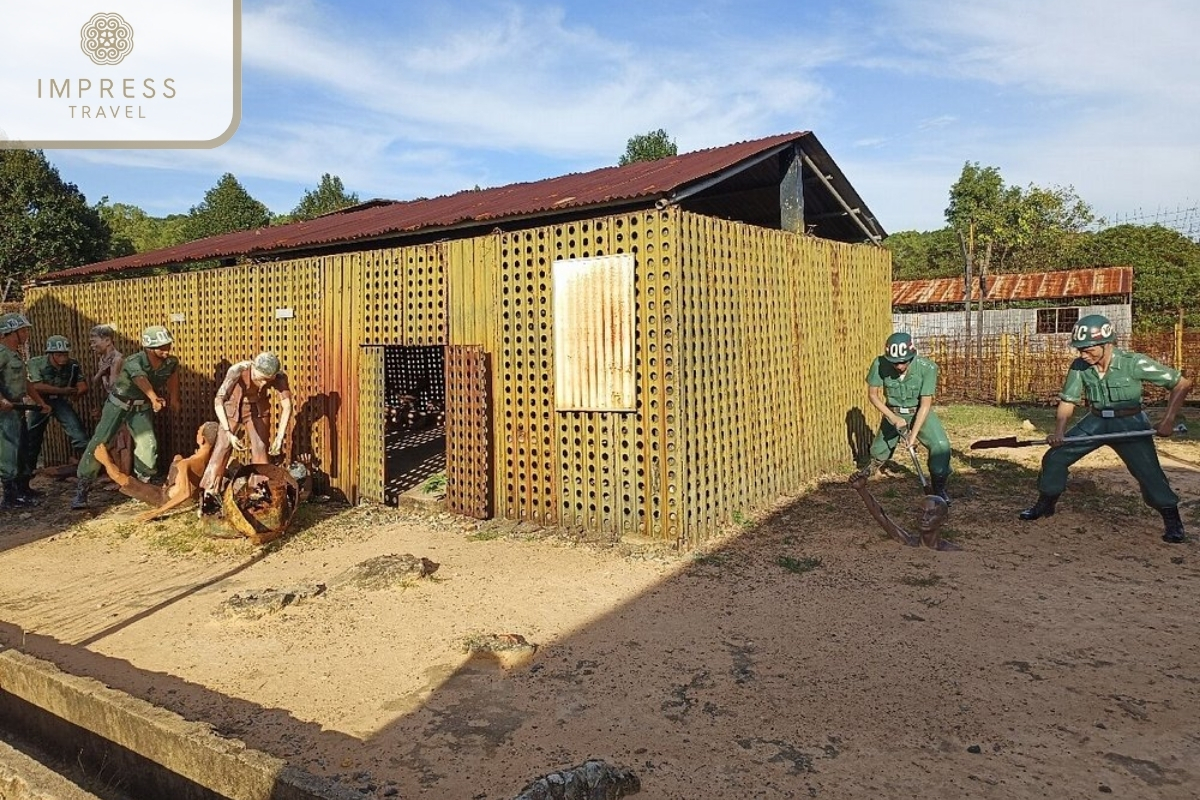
[866,356,950,479]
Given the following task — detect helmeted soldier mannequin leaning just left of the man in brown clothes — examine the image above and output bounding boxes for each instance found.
[71,325,179,509]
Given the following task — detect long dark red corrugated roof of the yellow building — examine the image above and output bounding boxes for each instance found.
[37,131,812,283]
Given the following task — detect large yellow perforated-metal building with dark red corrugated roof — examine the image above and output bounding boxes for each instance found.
[25,132,892,547]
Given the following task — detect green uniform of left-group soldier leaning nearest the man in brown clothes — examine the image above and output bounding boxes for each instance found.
[76,350,179,481]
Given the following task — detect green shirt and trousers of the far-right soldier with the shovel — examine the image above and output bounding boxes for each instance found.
[1038,348,1181,509]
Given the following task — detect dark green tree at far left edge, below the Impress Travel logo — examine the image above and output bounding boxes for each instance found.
[0,150,112,296]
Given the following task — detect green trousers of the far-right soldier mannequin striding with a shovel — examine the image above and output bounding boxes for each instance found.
[1038,413,1180,509]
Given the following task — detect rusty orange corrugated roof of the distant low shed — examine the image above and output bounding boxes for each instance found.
[892,266,1133,308]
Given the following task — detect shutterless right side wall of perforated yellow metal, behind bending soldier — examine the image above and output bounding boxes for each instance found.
[665,213,892,546]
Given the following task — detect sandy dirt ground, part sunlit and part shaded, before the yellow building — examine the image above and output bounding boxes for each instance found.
[0,409,1200,800]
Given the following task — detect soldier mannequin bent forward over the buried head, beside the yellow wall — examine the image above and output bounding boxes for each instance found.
[863,333,950,503]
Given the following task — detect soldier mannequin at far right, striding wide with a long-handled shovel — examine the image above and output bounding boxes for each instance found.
[1019,314,1192,543]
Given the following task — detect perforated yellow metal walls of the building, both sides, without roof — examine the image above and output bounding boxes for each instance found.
[28,209,890,546]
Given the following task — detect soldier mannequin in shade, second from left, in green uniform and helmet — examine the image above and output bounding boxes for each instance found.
[20,336,88,495]
